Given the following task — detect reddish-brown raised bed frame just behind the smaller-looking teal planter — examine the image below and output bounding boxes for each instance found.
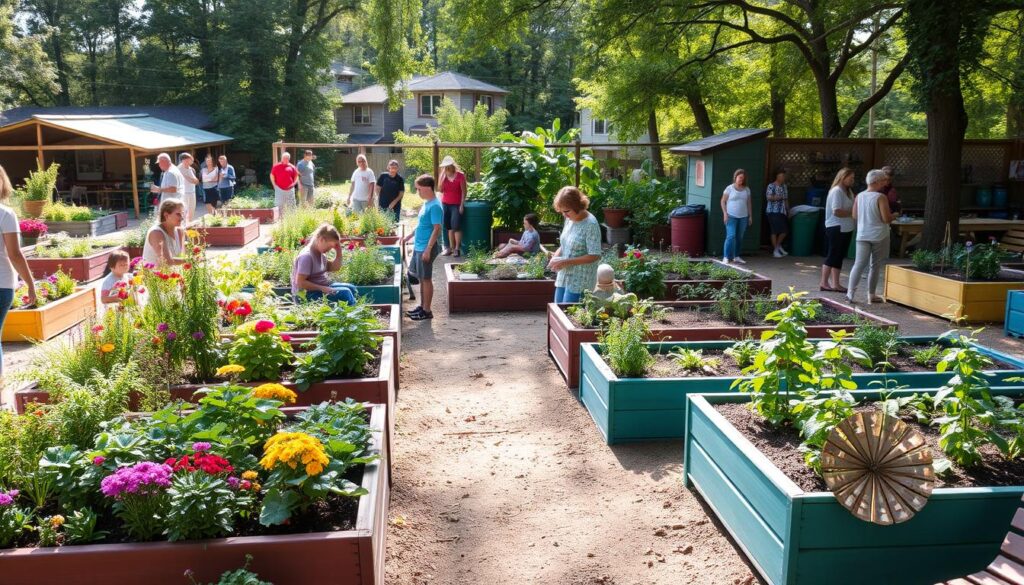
[548,298,899,388]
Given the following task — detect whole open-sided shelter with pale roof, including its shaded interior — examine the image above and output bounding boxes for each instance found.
[0,113,232,217]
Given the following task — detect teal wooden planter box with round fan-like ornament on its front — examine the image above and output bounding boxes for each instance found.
[683,391,1024,585]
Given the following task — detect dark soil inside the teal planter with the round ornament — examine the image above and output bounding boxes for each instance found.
[714,404,1024,492]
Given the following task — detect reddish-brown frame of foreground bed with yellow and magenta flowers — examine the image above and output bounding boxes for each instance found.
[0,405,390,585]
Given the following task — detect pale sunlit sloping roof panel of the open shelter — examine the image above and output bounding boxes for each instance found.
[26,114,233,152]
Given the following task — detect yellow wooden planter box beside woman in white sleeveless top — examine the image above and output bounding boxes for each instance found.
[885,264,1024,323]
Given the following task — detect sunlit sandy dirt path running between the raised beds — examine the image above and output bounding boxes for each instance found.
[387,260,755,585]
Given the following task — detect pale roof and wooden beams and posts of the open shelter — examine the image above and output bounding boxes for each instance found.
[0,114,232,218]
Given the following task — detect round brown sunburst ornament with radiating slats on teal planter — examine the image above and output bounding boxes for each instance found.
[821,411,935,526]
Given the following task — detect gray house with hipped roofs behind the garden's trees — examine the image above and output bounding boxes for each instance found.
[335,71,509,144]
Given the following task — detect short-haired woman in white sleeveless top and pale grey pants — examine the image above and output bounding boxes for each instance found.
[846,169,893,304]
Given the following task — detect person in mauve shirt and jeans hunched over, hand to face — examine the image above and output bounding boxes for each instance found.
[292,223,356,304]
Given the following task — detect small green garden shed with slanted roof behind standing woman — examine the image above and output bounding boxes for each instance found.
[669,128,771,253]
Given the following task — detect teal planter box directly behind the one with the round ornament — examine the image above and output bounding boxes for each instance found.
[580,337,1024,445]
